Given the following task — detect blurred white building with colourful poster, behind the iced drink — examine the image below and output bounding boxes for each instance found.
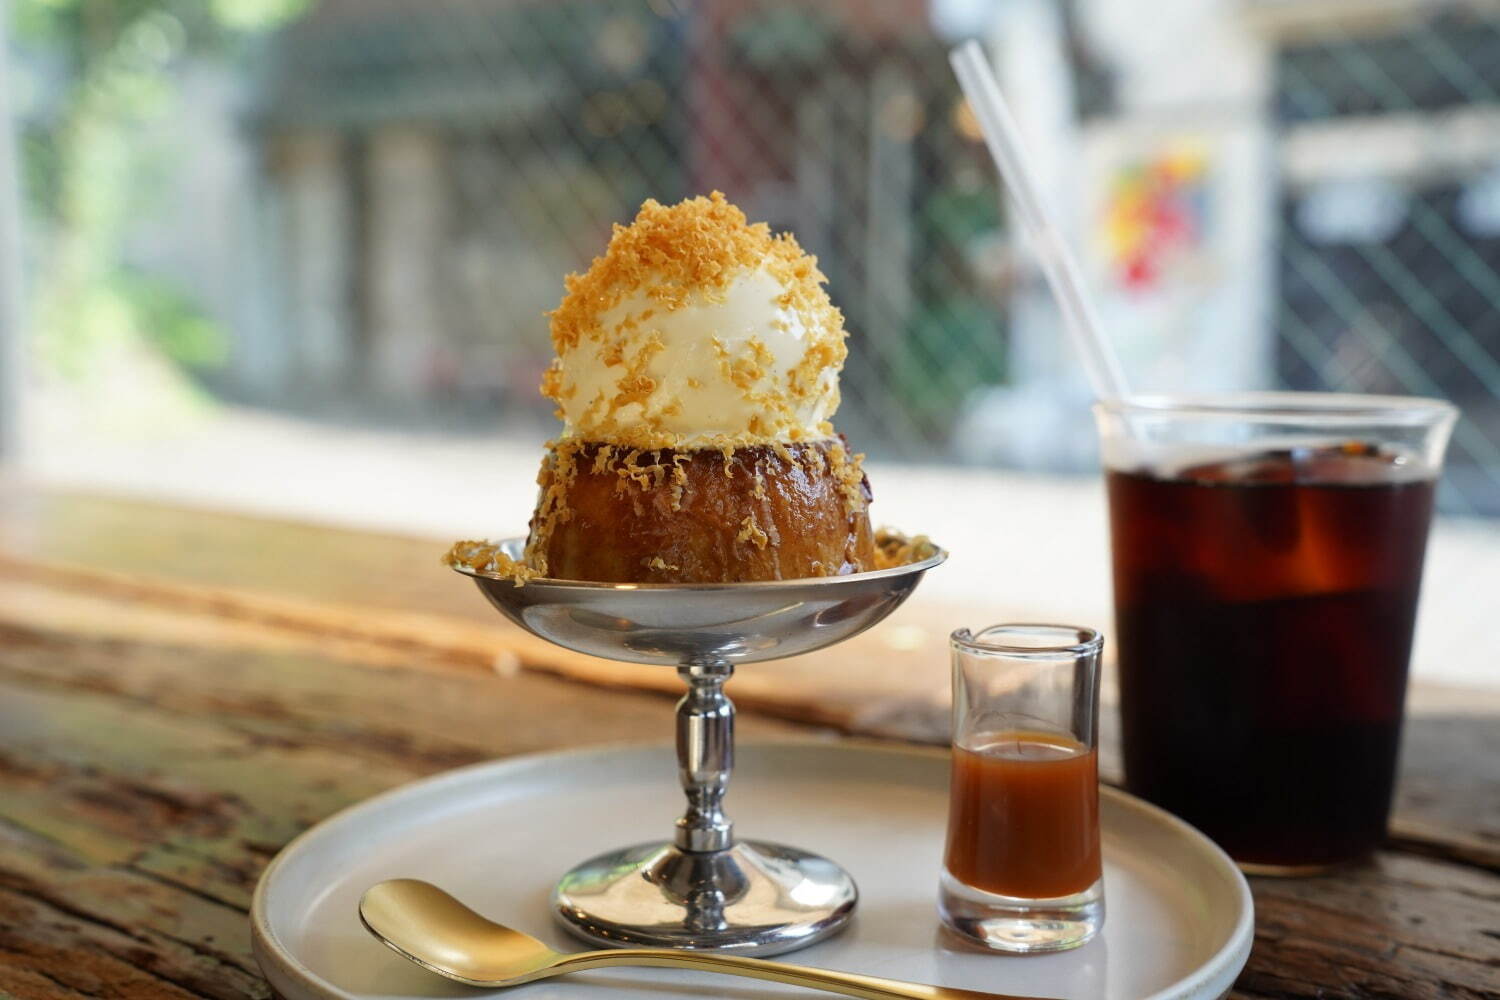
[960,0,1500,514]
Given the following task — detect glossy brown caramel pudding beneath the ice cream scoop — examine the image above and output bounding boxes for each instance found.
[527,438,876,583]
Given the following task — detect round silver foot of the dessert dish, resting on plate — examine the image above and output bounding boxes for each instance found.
[552,841,858,955]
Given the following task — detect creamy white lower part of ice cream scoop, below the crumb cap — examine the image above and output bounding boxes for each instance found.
[558,268,839,448]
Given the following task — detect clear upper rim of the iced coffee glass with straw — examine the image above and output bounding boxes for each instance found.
[1094,391,1458,424]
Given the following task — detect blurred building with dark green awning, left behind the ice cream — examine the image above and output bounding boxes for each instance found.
[240,0,683,411]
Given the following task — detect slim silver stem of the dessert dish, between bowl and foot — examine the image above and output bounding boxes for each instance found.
[677,660,735,852]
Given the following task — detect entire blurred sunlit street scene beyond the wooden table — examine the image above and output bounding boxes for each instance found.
[0,0,1500,680]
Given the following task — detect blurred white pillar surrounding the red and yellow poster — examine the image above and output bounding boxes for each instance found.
[1080,0,1278,391]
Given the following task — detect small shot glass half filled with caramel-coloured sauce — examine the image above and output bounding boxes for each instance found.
[938,625,1104,952]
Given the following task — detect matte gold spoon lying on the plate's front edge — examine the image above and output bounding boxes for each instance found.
[360,879,1044,1000]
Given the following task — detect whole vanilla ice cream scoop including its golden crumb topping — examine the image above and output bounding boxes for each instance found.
[542,192,846,448]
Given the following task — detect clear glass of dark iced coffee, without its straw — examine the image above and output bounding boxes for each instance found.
[1095,393,1457,874]
